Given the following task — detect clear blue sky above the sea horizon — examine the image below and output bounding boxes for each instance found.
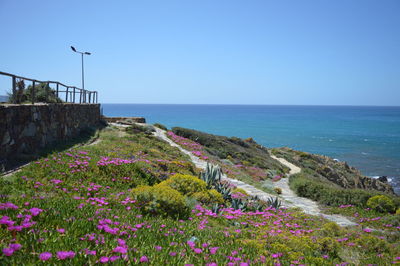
[0,0,400,105]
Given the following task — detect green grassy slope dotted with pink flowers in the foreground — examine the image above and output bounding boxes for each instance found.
[0,128,400,265]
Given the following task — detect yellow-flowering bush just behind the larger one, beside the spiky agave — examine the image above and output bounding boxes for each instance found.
[158,174,207,196]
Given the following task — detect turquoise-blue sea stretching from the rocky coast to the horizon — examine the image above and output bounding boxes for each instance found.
[101,104,400,194]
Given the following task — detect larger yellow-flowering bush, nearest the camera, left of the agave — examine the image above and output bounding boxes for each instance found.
[131,186,190,219]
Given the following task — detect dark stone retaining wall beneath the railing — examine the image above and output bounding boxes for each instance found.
[0,103,100,167]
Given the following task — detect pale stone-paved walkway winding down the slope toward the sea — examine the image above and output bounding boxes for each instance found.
[154,127,356,226]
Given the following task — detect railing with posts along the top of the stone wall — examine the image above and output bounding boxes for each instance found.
[0,71,98,104]
